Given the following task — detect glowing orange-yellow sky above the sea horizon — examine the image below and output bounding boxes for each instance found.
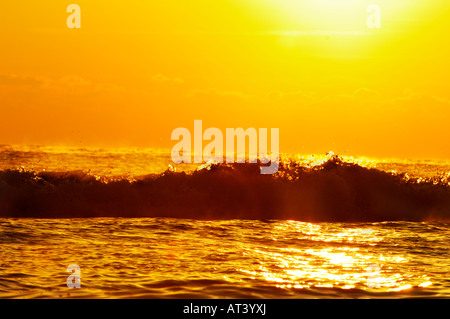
[0,0,450,159]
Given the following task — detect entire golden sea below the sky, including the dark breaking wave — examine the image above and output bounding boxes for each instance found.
[0,145,450,298]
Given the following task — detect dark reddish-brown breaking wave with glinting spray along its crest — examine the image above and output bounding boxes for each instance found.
[0,156,450,222]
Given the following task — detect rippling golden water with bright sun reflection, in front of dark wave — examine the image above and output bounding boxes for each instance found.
[0,218,450,298]
